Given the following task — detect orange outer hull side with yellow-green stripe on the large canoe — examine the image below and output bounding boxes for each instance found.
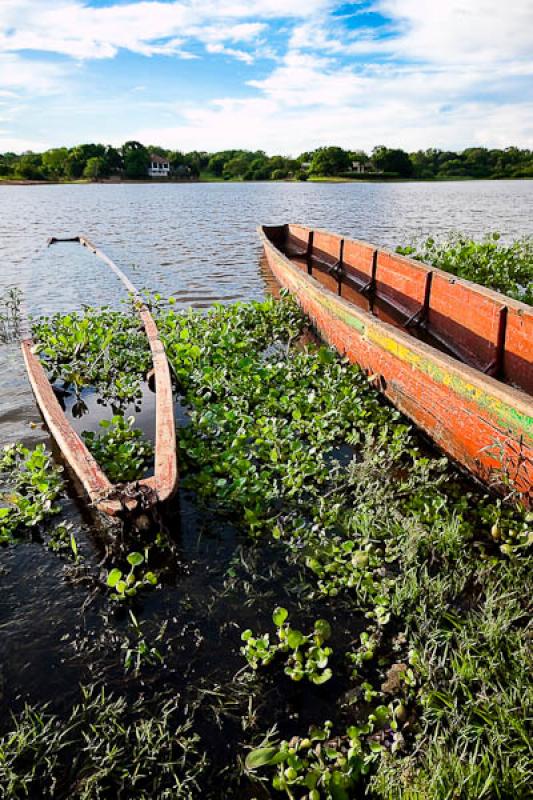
[260,229,533,505]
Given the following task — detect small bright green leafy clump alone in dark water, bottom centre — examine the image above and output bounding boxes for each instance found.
[241,606,333,685]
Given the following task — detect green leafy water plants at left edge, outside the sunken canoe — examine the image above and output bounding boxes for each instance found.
[0,444,63,543]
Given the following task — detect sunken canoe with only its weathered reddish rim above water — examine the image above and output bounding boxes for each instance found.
[22,236,178,516]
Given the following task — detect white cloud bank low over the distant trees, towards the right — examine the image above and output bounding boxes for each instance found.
[134,98,533,155]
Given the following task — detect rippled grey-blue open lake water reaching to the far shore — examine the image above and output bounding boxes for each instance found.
[0,181,533,443]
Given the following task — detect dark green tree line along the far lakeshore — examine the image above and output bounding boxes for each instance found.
[0,141,533,181]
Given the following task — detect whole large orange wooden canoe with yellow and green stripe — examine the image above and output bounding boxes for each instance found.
[259,224,533,505]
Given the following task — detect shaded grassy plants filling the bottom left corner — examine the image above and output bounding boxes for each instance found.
[0,686,207,800]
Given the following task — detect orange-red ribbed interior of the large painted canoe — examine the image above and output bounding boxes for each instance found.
[263,225,533,394]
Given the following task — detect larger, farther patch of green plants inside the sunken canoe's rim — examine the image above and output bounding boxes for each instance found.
[33,308,152,406]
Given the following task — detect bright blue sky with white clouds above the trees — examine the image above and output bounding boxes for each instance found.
[0,0,533,155]
